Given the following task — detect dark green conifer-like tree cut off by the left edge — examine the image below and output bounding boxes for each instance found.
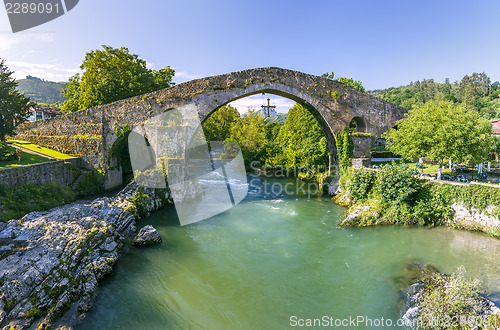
[0,60,33,142]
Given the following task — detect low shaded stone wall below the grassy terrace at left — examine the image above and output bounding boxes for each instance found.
[0,158,81,187]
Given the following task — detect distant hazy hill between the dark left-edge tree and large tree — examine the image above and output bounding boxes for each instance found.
[17,76,67,104]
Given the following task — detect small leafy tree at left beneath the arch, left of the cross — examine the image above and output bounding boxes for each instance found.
[202,105,240,142]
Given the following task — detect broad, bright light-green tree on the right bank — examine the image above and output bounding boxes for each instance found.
[383,101,493,178]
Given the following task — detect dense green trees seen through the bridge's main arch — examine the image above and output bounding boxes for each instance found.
[202,104,329,174]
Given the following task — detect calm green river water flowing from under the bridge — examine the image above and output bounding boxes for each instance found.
[76,178,500,329]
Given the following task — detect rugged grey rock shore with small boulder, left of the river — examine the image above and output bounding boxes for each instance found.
[0,182,171,329]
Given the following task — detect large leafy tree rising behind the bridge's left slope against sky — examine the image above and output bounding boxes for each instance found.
[62,45,175,112]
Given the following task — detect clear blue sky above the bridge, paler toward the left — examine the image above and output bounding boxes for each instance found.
[0,0,500,112]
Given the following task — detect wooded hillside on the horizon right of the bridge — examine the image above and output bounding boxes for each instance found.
[371,72,500,119]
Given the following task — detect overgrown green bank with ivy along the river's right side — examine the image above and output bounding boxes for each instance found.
[334,164,500,237]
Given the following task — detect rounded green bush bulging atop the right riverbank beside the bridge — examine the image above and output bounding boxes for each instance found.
[376,162,418,204]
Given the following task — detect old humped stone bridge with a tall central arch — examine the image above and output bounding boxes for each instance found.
[15,67,407,188]
